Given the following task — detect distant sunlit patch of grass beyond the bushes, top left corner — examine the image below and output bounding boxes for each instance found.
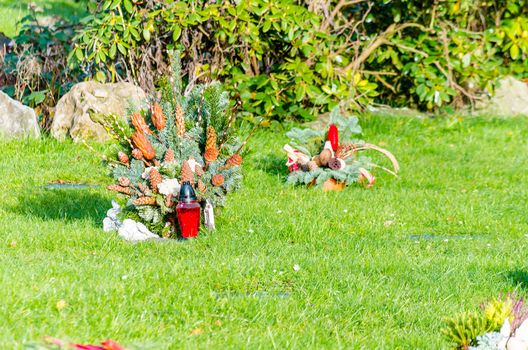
[0,0,85,37]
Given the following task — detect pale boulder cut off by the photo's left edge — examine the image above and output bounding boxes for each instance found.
[0,91,40,138]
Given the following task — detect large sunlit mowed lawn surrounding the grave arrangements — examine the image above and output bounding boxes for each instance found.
[0,116,528,349]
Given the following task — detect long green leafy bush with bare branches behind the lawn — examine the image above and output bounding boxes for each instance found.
[70,0,528,119]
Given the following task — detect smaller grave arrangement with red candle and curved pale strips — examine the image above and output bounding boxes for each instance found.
[284,108,399,191]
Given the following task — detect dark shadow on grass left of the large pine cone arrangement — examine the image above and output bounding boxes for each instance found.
[11,189,111,226]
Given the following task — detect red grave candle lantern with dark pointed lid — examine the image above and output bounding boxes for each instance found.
[176,181,200,238]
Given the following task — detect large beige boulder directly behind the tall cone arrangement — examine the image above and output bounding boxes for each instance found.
[51,81,147,142]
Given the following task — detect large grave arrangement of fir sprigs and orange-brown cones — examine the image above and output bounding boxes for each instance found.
[92,55,247,237]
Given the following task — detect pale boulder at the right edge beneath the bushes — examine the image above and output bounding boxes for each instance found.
[483,77,528,116]
